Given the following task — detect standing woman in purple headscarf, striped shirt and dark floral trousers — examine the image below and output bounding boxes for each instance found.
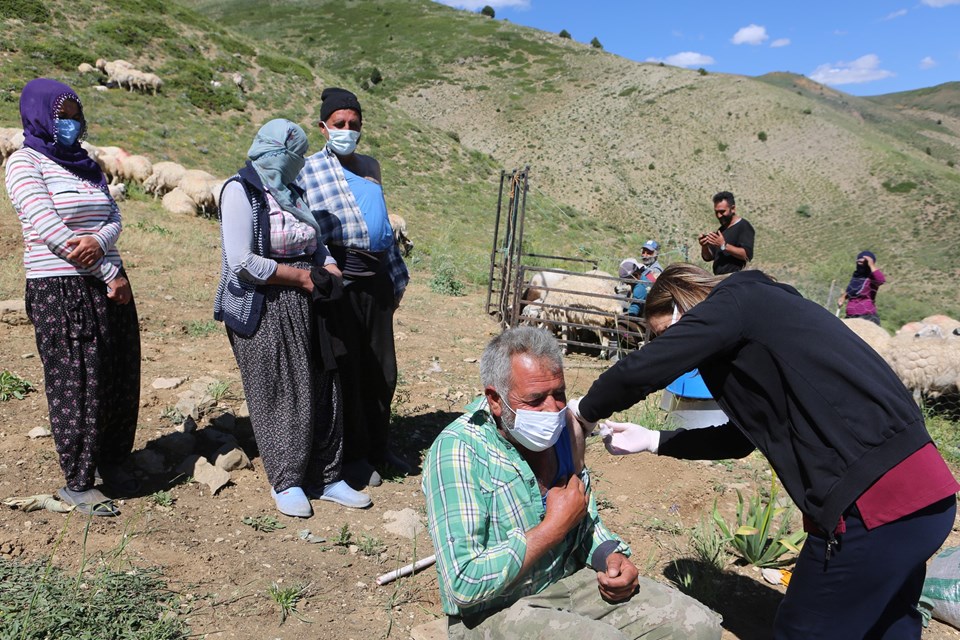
[6,78,140,516]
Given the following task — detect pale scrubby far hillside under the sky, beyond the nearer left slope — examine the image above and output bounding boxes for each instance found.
[199,0,960,322]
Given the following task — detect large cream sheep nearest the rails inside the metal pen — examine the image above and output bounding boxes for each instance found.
[541,271,623,358]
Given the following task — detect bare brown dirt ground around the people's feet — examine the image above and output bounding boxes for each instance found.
[0,205,960,640]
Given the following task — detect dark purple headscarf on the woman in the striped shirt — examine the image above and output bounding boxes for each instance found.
[20,78,107,190]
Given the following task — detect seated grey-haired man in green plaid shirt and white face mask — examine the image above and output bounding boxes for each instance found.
[423,327,720,639]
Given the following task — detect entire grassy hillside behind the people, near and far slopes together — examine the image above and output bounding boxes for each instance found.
[0,0,960,324]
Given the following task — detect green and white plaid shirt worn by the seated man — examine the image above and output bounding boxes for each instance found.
[422,402,630,616]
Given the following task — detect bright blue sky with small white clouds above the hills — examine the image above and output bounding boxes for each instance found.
[437,0,960,95]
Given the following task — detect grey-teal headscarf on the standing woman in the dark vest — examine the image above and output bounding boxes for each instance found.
[247,118,320,233]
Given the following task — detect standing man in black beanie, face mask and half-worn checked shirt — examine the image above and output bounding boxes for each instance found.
[298,88,410,487]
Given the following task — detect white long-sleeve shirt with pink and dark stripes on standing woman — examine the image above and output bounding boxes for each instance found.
[6,148,123,282]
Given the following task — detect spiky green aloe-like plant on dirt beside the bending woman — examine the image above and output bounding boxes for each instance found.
[713,474,807,567]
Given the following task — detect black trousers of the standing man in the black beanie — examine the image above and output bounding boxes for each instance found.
[336,273,397,463]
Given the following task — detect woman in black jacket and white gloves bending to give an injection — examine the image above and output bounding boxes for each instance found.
[571,264,960,640]
